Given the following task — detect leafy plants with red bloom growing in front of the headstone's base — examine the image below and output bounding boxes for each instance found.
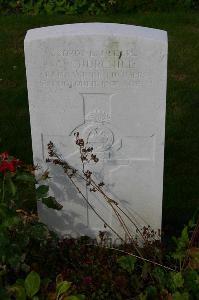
[0,152,199,300]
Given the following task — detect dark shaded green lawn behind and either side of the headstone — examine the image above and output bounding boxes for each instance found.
[0,13,199,234]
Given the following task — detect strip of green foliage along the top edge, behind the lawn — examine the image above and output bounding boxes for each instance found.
[0,0,198,15]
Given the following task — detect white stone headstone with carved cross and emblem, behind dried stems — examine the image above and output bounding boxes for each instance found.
[25,23,167,241]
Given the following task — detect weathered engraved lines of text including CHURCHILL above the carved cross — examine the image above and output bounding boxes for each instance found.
[39,44,151,89]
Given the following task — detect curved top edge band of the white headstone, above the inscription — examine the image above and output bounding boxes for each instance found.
[25,23,167,43]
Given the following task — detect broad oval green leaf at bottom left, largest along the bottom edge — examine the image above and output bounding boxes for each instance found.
[25,271,41,297]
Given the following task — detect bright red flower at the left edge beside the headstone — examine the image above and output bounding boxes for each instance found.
[0,152,21,174]
